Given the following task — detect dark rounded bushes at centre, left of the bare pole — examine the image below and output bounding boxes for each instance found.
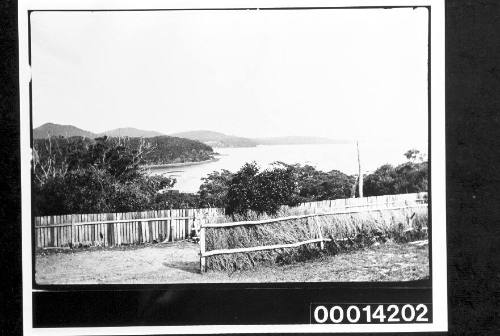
[199,162,355,216]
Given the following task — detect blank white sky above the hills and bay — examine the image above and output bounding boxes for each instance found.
[31,8,428,144]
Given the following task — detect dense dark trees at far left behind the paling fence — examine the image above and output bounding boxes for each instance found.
[33,137,175,215]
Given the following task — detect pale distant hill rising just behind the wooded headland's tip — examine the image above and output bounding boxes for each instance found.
[171,130,258,147]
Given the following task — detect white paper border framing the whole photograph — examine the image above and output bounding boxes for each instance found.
[18,0,448,335]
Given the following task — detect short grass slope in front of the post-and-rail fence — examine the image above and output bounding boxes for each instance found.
[210,241,429,282]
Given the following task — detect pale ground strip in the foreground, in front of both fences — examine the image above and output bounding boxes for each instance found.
[35,241,429,284]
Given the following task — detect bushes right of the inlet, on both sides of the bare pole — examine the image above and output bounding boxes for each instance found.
[194,150,428,216]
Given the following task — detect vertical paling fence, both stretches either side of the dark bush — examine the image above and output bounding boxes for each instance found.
[34,193,427,248]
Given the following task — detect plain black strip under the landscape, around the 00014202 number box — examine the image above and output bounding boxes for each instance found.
[33,284,432,327]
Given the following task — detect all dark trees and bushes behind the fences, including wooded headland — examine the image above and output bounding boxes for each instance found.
[33,137,428,216]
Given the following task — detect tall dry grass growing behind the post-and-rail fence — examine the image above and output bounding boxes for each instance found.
[206,208,427,272]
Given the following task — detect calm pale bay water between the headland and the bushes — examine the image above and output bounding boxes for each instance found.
[148,143,426,192]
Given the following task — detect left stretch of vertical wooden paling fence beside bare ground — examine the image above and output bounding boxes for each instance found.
[35,208,224,248]
